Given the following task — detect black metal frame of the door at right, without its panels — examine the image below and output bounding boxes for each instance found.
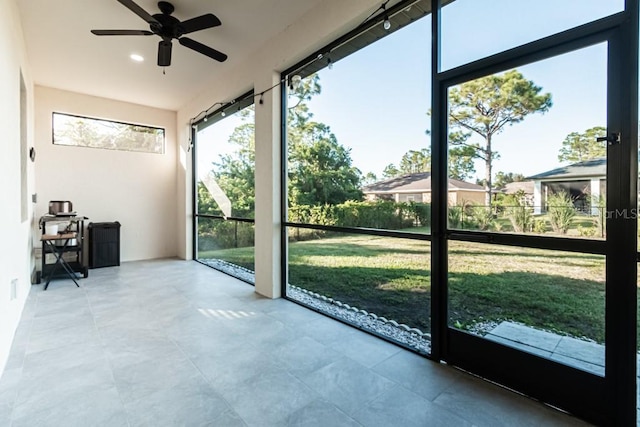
[431,0,638,425]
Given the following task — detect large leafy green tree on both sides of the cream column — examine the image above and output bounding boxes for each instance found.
[213,75,362,216]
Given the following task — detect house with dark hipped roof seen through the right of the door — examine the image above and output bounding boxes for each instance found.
[529,157,607,215]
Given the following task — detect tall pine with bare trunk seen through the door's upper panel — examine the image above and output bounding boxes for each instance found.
[449,70,552,206]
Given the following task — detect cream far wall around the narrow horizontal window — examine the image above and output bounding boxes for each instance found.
[35,86,178,260]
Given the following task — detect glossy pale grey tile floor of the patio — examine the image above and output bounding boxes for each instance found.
[0,260,587,427]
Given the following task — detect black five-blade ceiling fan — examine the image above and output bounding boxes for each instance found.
[91,0,227,67]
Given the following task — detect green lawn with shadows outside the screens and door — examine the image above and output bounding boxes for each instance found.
[200,231,636,342]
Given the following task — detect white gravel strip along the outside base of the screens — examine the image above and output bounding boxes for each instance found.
[198,259,431,354]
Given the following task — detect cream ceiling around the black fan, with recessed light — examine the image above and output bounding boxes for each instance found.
[18,0,322,110]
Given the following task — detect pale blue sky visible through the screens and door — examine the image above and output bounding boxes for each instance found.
[199,0,623,181]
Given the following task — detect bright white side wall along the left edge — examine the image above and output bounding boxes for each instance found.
[0,0,34,373]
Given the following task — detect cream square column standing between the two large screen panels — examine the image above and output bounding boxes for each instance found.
[254,72,282,298]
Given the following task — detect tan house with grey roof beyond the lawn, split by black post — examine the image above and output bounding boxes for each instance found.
[362,172,484,206]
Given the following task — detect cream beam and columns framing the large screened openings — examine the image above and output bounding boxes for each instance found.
[178,0,380,297]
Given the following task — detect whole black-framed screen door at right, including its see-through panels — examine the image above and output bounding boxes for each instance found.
[436,24,636,423]
